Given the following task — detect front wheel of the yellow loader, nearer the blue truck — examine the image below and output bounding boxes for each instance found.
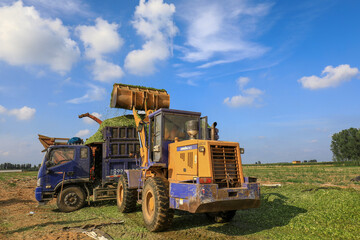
[116,174,137,213]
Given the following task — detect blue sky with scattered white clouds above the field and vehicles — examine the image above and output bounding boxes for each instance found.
[0,0,360,164]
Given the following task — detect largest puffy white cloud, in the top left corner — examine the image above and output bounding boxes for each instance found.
[0,1,80,73]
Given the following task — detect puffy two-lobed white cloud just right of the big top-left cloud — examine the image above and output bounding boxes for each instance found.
[76,18,124,82]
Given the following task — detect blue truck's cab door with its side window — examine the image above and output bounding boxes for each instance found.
[45,147,76,191]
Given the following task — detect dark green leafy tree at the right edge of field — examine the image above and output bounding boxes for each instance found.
[330,128,360,162]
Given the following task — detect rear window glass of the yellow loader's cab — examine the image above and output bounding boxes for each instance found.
[164,113,199,141]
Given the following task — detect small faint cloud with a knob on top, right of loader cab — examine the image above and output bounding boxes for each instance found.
[224,77,264,108]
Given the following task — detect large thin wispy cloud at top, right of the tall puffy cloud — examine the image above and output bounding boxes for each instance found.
[180,0,271,68]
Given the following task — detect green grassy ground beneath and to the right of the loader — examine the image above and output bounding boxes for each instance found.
[0,165,360,239]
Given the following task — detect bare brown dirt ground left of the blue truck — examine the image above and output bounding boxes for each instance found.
[0,177,93,240]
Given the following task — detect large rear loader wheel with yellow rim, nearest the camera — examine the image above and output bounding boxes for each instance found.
[142,177,174,232]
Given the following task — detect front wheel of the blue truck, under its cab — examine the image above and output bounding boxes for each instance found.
[56,187,85,212]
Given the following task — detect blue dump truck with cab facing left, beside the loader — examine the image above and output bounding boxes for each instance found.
[35,126,140,212]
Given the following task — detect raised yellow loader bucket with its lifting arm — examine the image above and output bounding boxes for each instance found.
[110,84,170,167]
